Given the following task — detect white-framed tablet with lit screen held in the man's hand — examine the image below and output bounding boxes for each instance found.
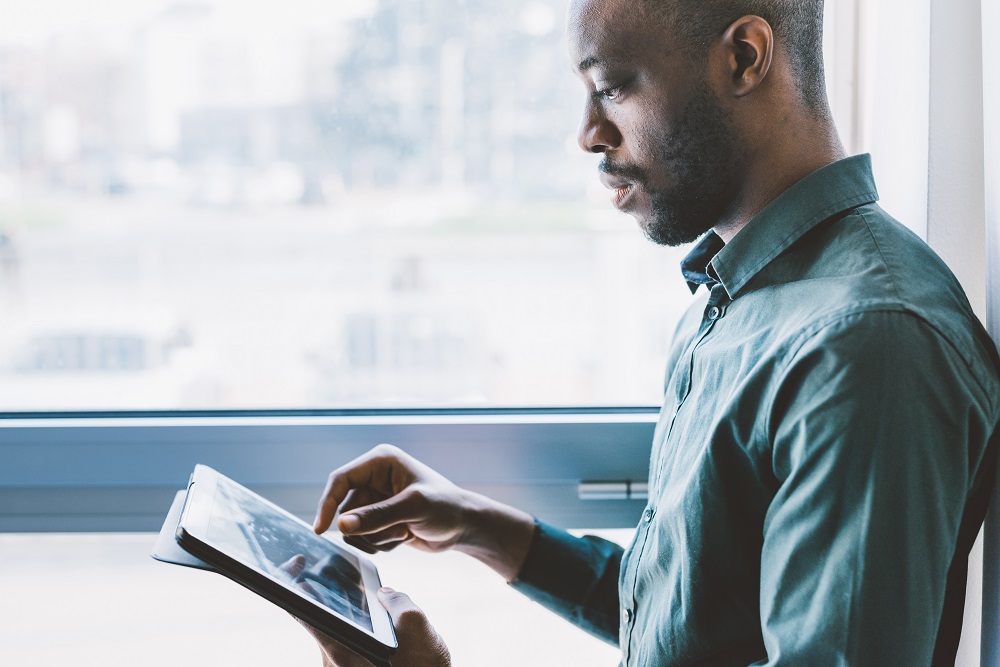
[176,465,396,664]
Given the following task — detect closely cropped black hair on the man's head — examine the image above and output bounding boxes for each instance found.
[646,0,829,115]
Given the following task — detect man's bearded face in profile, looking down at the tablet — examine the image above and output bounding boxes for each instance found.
[568,0,739,245]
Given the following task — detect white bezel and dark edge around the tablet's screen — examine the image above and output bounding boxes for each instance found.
[176,464,397,659]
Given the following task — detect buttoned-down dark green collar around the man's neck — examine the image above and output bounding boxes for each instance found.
[681,155,878,299]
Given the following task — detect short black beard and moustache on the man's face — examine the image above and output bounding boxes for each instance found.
[599,83,739,246]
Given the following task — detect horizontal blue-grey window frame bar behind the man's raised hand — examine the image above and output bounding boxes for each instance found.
[0,407,658,532]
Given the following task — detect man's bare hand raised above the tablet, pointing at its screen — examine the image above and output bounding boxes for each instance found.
[314,445,534,581]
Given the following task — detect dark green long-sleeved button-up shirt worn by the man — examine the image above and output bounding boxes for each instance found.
[514,156,1000,667]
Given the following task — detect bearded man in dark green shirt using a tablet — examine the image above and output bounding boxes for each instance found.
[300,0,1000,667]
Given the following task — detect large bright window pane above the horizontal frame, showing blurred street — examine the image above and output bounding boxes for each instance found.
[0,0,691,410]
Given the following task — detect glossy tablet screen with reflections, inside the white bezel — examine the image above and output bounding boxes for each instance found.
[207,478,373,631]
